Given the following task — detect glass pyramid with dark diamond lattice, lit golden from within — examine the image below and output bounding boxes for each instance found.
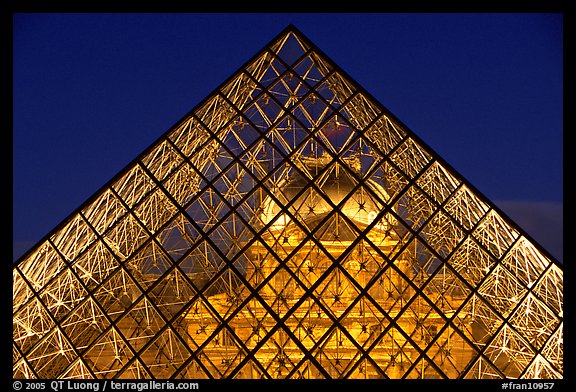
[13,26,563,379]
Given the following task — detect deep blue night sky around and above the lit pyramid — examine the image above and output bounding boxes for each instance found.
[13,13,563,261]
